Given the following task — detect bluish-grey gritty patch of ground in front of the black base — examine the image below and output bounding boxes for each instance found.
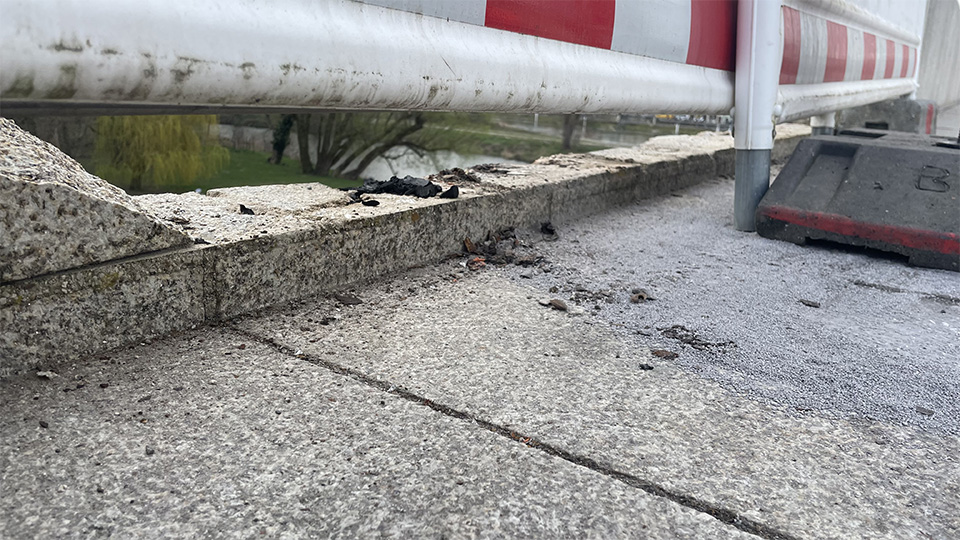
[496,175,960,435]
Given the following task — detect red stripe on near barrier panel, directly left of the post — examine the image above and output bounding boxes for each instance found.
[687,0,737,71]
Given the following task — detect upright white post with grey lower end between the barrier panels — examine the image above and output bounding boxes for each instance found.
[733,0,781,231]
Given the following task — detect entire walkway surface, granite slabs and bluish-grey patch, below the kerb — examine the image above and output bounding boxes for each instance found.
[0,175,960,539]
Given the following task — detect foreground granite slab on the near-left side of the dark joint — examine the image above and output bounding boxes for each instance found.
[0,328,751,539]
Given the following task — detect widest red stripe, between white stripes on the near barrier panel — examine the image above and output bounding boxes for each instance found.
[484,0,617,49]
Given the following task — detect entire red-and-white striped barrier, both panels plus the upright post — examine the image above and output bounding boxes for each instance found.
[0,0,927,230]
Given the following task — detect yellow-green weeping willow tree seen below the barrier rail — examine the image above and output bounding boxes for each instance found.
[93,115,230,193]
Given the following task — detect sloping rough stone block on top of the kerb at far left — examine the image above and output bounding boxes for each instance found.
[0,118,191,283]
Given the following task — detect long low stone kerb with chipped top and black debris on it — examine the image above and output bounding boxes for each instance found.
[0,125,810,375]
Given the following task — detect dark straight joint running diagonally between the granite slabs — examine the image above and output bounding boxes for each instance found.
[230,325,800,540]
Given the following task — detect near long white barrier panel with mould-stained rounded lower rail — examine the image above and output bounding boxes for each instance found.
[0,0,736,114]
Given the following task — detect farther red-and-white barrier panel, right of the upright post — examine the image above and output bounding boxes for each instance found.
[778,0,926,122]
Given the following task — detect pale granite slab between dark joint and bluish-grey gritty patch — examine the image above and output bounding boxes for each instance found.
[239,264,960,539]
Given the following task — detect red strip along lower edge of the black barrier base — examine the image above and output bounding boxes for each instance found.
[760,206,960,255]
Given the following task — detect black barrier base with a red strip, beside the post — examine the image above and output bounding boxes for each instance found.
[757,130,960,271]
